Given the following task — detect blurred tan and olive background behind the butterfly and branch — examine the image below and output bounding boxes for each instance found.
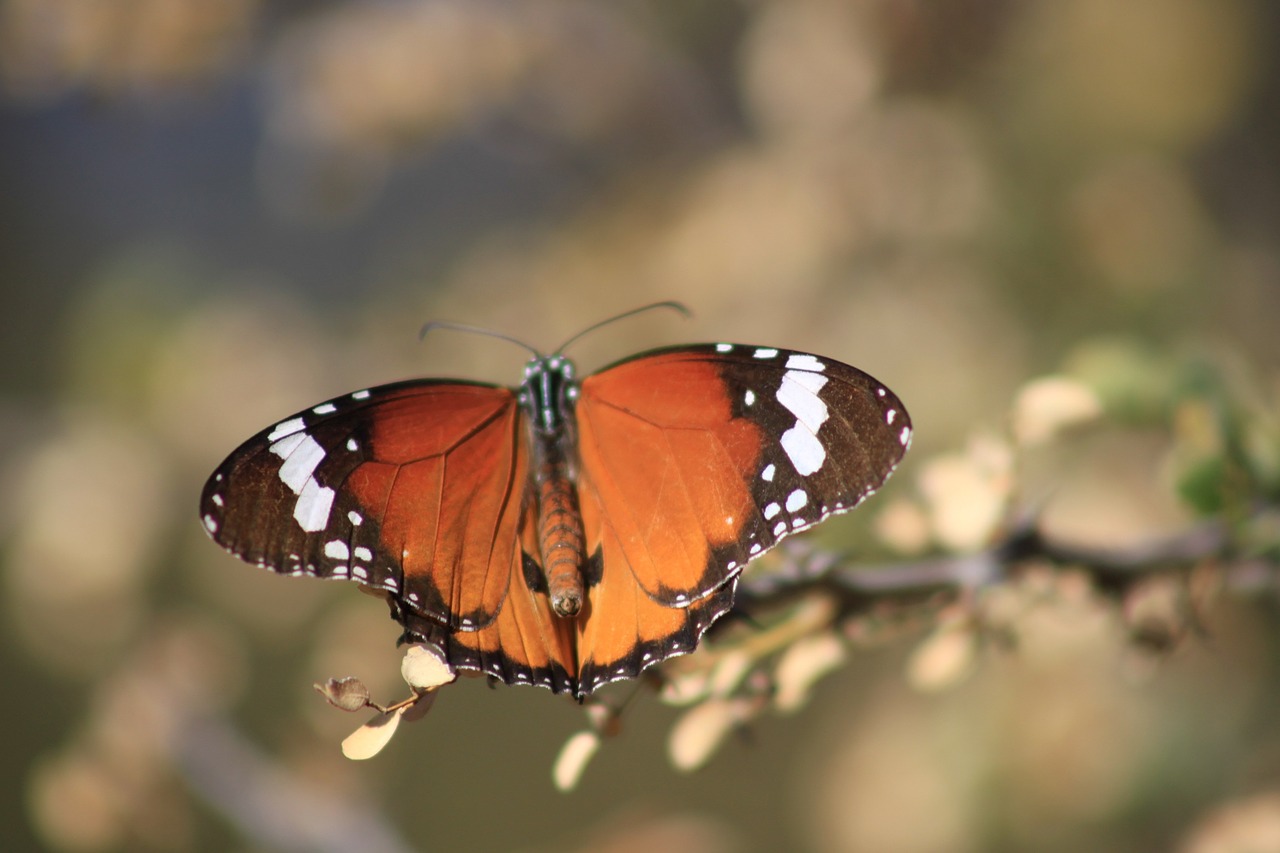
[0,0,1280,852]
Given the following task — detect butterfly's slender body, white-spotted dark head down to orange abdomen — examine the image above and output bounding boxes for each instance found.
[520,355,585,617]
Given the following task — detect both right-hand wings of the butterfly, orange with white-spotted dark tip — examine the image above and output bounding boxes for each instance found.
[576,345,911,681]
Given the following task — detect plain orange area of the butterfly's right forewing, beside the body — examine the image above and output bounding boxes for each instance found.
[577,353,762,607]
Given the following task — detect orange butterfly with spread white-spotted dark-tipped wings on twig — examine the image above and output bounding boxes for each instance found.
[200,308,911,699]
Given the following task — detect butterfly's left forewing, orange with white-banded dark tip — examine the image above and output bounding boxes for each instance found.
[201,380,527,630]
